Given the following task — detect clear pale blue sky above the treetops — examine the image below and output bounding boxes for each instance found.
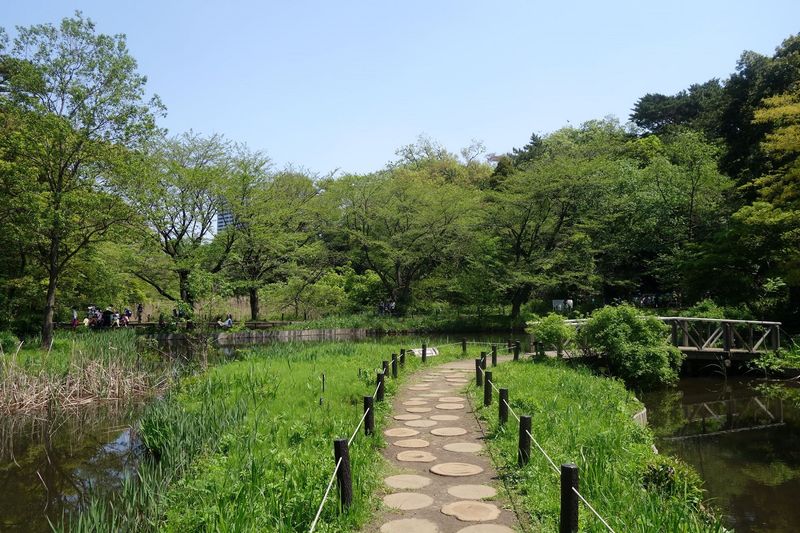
[0,0,800,174]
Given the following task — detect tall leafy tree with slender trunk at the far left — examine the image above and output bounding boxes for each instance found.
[0,12,162,345]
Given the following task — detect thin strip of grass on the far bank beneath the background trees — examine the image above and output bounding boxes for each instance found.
[281,312,525,333]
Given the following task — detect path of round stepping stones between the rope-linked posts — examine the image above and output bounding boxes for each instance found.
[366,359,517,533]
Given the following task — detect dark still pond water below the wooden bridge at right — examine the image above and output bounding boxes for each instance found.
[642,377,800,533]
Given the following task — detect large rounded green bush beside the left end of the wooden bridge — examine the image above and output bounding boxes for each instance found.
[581,304,683,389]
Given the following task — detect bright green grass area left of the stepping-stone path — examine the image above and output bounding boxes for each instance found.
[61,339,472,532]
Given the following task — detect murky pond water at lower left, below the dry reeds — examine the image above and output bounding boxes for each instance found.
[0,404,137,531]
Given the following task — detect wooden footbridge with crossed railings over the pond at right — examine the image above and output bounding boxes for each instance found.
[566,316,781,361]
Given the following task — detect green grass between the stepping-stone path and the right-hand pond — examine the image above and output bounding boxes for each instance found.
[471,361,724,533]
